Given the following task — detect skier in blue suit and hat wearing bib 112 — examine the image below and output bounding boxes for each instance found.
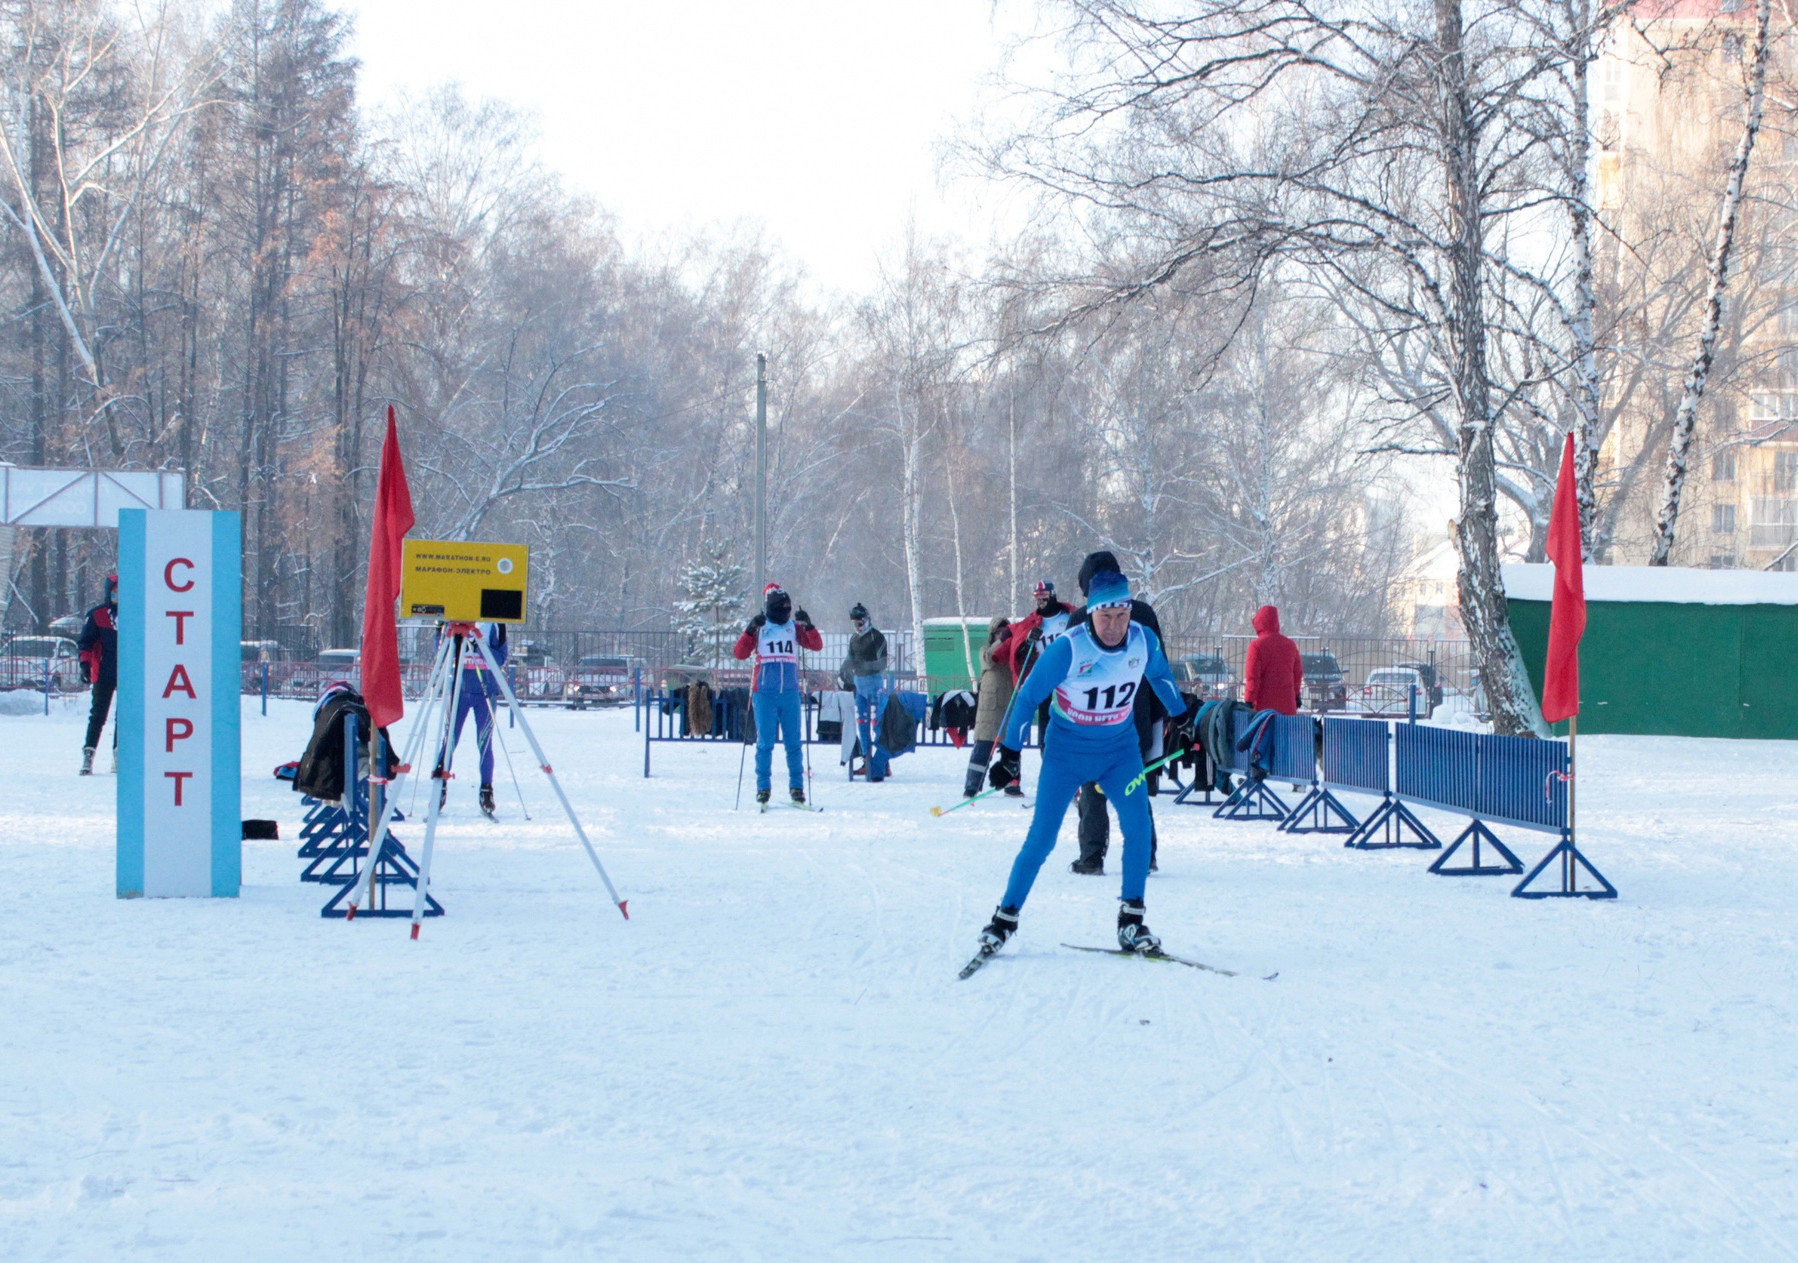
[980,570,1190,954]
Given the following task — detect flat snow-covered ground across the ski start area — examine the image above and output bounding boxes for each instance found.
[0,700,1798,1263]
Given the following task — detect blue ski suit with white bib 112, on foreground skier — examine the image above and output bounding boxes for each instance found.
[1000,623,1187,909]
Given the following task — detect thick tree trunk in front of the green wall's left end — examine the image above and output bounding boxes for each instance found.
[1435,0,1546,736]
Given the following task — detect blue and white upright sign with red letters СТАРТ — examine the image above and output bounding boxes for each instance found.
[119,509,243,900]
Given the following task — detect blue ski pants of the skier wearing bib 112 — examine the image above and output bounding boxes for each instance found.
[1001,723,1153,909]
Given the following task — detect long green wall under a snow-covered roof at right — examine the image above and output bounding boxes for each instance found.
[1510,599,1798,739]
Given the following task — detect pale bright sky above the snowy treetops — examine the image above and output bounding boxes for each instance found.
[345,0,1001,290]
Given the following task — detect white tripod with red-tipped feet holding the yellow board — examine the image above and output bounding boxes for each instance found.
[345,623,631,939]
